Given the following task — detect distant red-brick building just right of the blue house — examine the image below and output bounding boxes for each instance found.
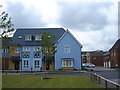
[82,50,104,66]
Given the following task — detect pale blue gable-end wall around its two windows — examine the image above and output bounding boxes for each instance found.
[55,32,81,69]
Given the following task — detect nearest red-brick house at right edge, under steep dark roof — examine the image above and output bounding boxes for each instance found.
[109,39,120,67]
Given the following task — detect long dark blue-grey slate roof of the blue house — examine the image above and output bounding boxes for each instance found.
[12,28,65,45]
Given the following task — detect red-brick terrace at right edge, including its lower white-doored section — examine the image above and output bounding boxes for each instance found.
[104,39,120,67]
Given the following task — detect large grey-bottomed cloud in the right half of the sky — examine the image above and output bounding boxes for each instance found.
[59,2,112,31]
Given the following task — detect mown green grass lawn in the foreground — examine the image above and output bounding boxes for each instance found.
[2,75,103,88]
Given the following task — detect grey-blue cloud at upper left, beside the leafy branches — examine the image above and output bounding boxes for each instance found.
[3,2,47,28]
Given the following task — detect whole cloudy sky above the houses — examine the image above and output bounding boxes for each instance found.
[0,0,118,51]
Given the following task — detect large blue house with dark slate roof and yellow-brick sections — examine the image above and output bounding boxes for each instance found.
[5,28,82,71]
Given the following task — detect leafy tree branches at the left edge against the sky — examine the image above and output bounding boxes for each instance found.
[0,6,14,46]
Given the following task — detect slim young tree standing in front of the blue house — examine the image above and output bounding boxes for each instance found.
[40,32,56,78]
